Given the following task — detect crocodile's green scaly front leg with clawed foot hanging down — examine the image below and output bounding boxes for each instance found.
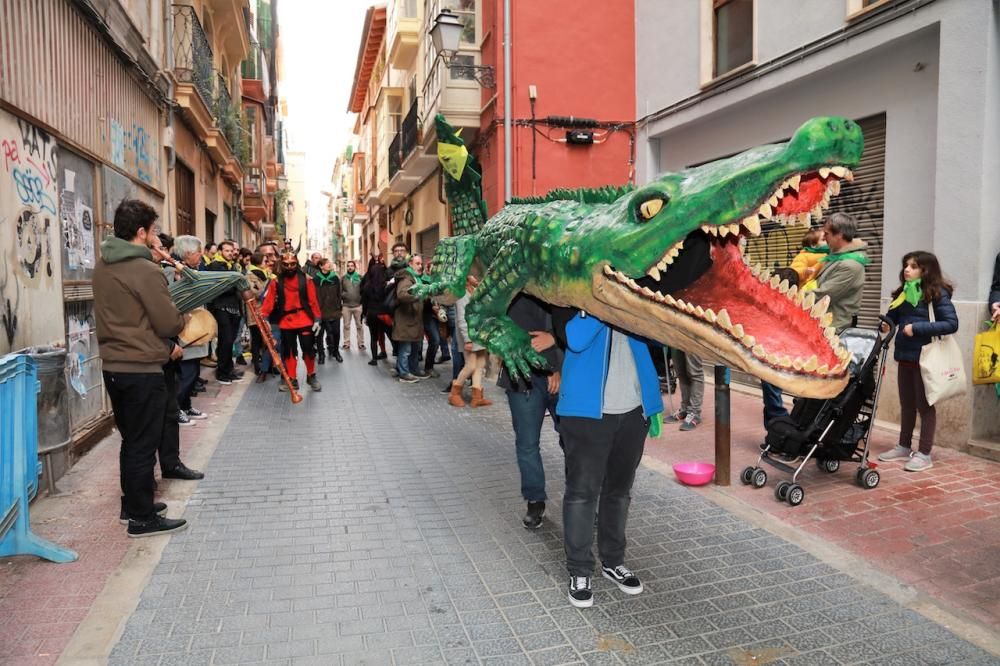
[465,240,547,379]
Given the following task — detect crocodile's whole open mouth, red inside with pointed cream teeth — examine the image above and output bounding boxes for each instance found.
[603,166,853,378]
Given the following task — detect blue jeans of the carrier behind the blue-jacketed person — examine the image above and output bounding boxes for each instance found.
[507,375,560,500]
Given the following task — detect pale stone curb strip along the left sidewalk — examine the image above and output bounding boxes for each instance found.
[56,380,252,666]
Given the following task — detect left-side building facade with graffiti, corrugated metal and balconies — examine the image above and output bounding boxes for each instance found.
[0,0,282,477]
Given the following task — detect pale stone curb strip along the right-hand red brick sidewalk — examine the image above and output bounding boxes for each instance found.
[642,455,1000,656]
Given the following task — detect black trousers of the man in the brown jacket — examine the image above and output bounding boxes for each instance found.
[104,370,167,521]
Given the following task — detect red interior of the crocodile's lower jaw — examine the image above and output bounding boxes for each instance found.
[672,239,839,368]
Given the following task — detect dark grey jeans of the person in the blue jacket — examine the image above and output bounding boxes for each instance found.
[559,407,649,576]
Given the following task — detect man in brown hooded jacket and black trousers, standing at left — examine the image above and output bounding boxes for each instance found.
[94,199,188,537]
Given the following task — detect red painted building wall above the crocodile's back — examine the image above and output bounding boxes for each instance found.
[478,0,636,215]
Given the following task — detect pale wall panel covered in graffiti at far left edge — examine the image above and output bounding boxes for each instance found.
[0,112,63,354]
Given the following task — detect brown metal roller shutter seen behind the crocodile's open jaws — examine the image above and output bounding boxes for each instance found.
[747,113,885,328]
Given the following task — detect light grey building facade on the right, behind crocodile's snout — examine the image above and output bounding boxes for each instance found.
[636,0,1000,453]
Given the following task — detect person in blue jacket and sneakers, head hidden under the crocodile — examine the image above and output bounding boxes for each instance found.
[556,312,663,608]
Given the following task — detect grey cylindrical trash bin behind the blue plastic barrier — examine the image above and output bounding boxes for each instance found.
[16,346,71,498]
